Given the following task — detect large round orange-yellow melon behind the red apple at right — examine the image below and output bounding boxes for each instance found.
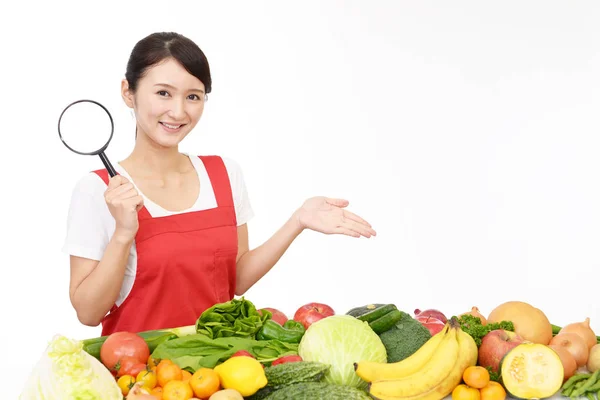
[487,301,552,345]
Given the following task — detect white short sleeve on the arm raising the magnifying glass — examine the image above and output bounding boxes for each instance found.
[62,173,112,261]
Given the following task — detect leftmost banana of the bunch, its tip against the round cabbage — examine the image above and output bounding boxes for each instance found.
[354,324,450,382]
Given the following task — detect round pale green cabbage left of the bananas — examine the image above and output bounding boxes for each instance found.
[298,315,387,389]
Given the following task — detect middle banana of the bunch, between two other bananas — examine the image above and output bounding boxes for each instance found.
[369,326,460,399]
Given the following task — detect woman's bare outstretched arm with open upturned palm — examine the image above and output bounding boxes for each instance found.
[235,197,376,296]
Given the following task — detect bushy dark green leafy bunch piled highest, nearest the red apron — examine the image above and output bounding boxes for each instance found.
[196,297,271,339]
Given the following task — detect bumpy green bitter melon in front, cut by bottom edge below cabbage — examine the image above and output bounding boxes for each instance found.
[265,382,372,400]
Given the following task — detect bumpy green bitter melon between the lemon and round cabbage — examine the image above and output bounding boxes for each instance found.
[247,361,330,400]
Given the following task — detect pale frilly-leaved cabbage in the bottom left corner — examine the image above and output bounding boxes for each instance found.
[19,335,123,400]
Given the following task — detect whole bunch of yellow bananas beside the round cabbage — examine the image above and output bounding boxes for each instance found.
[354,318,477,400]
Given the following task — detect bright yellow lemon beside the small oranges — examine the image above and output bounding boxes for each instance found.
[214,357,267,397]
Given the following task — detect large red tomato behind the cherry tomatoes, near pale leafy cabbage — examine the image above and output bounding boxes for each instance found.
[100,332,150,370]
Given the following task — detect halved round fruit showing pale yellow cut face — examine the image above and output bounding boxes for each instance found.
[500,343,564,399]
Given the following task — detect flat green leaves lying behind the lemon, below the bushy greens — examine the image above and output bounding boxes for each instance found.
[152,334,298,373]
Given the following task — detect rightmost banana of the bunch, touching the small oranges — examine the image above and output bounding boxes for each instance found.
[368,329,477,400]
